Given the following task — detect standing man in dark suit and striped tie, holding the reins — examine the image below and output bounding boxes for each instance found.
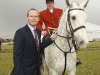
[10,9,57,75]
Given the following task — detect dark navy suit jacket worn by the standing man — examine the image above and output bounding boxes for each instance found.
[10,25,52,75]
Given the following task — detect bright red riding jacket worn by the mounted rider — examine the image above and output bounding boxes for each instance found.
[37,8,63,32]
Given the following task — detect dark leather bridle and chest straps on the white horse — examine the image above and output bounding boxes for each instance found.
[54,8,85,75]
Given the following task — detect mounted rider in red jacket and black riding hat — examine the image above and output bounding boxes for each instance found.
[37,0,63,35]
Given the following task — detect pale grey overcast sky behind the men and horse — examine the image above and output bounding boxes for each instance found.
[0,0,100,38]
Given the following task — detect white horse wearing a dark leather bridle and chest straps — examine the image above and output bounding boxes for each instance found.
[41,0,89,75]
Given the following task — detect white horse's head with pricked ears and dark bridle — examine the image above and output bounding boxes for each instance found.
[65,0,89,48]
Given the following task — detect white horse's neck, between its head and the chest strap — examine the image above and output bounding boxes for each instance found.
[55,8,72,50]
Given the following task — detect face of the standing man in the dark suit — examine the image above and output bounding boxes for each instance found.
[27,10,39,27]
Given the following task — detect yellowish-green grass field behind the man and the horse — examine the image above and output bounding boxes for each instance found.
[0,42,100,75]
